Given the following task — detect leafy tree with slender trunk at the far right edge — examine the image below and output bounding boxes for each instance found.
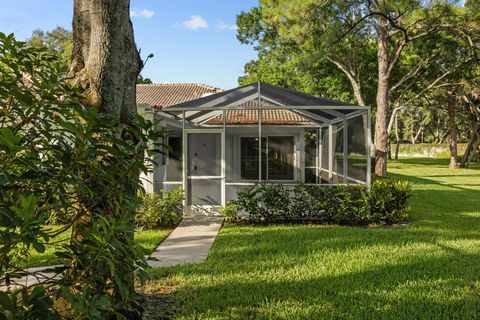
[388,2,480,169]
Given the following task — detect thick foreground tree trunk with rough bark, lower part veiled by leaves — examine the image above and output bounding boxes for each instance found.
[68,0,148,316]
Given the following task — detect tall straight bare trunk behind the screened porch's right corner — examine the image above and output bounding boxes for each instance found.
[375,17,389,177]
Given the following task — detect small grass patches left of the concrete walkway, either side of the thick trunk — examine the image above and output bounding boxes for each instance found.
[21,226,171,267]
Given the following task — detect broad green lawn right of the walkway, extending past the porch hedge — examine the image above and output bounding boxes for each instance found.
[144,159,480,319]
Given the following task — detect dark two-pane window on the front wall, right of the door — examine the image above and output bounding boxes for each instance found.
[240,136,295,180]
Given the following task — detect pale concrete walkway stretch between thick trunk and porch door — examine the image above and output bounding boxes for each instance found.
[148,214,223,268]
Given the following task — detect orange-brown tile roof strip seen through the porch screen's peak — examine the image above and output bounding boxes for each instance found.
[205,109,311,125]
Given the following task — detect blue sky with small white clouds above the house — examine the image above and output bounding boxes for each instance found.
[0,0,258,89]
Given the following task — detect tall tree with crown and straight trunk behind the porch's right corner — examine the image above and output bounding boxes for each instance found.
[240,0,456,176]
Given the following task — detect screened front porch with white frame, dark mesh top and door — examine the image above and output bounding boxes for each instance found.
[139,82,371,212]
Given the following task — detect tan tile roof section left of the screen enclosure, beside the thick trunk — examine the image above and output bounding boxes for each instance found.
[137,83,223,109]
